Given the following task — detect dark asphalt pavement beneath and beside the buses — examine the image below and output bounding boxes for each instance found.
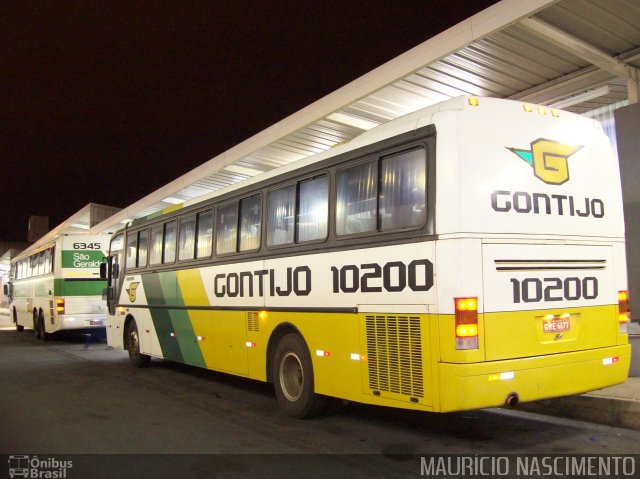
[0,329,640,477]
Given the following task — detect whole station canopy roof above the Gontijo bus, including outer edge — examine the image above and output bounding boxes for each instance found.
[92,0,640,232]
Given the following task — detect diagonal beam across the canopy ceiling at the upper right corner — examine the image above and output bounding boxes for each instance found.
[520,17,640,82]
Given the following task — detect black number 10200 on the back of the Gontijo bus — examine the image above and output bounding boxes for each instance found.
[511,276,598,303]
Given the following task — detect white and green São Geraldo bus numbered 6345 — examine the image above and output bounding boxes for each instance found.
[6,234,111,340]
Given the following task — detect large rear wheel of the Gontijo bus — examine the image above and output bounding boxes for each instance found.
[273,333,327,419]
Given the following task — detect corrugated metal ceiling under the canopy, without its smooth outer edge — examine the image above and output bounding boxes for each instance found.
[92,0,640,231]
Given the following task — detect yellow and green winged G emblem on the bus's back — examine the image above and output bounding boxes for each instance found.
[507,138,582,185]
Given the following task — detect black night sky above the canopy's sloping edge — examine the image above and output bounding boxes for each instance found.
[0,0,495,240]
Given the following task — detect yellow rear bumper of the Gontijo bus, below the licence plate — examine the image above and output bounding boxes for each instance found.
[438,344,631,412]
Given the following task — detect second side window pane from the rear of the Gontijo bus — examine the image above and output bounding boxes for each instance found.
[336,162,378,236]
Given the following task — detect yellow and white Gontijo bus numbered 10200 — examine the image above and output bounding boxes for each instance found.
[105,97,630,417]
